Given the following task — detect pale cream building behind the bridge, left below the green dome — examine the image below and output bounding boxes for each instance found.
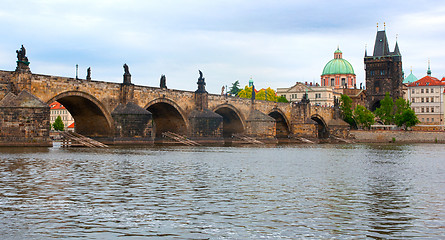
[277,82,340,107]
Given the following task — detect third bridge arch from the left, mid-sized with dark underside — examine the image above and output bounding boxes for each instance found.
[213,104,245,138]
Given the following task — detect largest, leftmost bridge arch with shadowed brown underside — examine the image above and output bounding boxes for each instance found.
[47,91,114,137]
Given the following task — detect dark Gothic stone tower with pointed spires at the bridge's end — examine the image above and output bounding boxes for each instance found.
[364,24,403,111]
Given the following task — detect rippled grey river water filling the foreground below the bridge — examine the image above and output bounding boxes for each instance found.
[0,144,445,239]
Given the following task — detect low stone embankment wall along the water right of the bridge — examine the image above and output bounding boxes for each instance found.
[350,130,445,143]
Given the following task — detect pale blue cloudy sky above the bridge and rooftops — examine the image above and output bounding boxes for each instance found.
[0,0,445,93]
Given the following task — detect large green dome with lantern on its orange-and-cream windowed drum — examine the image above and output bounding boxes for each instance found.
[320,48,357,91]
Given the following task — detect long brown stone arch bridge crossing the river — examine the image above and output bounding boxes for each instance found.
[0,58,349,143]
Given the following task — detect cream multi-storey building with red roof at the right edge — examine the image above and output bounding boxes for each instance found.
[408,67,445,125]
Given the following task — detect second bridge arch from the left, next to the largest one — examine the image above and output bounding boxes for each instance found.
[145,98,189,138]
